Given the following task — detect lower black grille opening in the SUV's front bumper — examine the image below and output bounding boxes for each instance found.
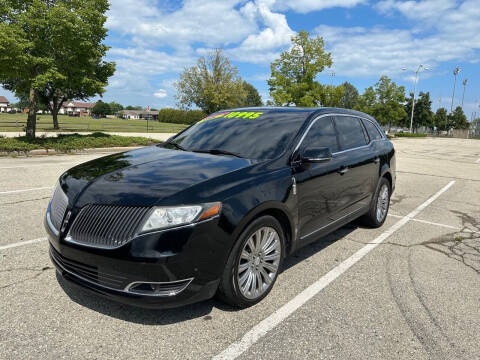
[50,246,126,290]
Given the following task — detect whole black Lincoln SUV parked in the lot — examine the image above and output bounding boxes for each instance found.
[45,107,395,307]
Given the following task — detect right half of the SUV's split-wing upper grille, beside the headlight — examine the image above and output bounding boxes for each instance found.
[67,204,150,248]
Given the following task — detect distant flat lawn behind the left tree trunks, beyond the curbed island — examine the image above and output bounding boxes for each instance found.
[0,113,188,133]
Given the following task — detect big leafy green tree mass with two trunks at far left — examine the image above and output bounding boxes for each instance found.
[0,0,115,138]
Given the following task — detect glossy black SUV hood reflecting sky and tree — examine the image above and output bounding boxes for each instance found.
[60,146,252,207]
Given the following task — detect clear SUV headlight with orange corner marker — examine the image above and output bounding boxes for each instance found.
[141,203,221,232]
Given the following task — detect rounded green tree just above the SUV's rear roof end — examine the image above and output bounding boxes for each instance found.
[355,76,406,127]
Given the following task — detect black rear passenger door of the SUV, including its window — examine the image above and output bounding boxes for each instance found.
[334,115,379,217]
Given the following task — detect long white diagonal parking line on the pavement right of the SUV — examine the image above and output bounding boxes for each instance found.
[213,181,455,360]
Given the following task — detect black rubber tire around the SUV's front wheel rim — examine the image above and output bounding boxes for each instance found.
[218,216,285,308]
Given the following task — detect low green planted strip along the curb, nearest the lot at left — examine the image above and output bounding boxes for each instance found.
[0,132,158,153]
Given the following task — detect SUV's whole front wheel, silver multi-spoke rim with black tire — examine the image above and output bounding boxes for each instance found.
[219,216,285,308]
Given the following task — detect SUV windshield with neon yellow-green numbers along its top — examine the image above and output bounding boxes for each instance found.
[165,110,306,160]
